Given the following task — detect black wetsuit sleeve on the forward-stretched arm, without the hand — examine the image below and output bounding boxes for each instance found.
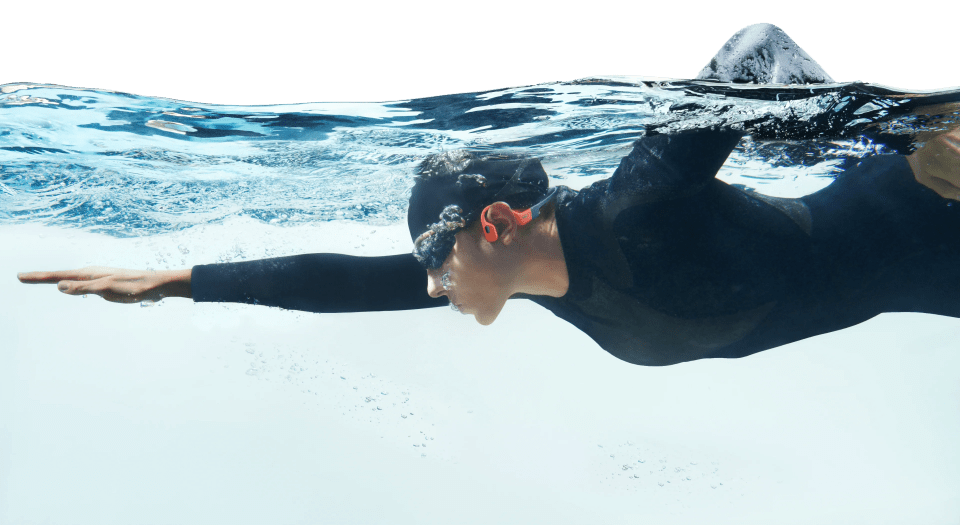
[190,253,448,313]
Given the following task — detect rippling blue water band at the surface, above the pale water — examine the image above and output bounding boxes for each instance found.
[0,77,960,237]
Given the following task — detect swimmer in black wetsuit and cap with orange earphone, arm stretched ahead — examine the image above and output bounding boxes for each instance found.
[18,23,960,366]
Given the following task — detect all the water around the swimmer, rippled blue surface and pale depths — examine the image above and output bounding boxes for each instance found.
[0,77,960,523]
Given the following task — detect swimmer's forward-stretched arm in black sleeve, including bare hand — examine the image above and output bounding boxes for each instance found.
[17,253,447,313]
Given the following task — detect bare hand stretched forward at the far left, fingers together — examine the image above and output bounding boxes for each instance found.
[17,266,191,303]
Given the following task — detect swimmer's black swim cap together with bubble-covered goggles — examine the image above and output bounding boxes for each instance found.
[407,150,549,269]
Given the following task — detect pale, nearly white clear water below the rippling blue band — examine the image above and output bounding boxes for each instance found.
[0,221,960,525]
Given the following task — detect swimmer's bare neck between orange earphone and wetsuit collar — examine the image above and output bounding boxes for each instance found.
[515,214,570,297]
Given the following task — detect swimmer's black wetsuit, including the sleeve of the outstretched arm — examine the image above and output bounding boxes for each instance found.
[192,127,960,366]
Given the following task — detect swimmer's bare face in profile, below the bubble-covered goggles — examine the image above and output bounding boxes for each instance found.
[427,221,511,325]
